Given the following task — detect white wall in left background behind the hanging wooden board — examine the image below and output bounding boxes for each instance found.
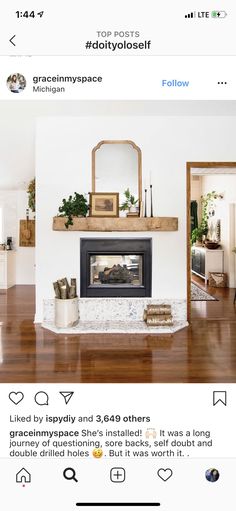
[0,190,35,285]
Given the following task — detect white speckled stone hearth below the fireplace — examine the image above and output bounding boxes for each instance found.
[42,298,188,335]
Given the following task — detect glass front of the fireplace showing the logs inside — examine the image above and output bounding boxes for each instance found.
[90,254,143,287]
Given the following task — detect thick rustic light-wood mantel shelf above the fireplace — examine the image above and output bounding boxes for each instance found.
[53,216,178,232]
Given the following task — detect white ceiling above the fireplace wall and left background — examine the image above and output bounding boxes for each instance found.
[0,101,236,190]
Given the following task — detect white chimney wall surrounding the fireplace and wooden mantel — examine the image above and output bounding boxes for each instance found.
[35,116,236,322]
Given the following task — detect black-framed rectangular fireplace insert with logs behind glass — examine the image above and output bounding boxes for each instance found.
[80,238,152,298]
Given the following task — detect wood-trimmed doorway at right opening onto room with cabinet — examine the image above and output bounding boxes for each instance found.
[186,162,236,321]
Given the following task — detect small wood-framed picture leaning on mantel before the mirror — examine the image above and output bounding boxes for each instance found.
[90,192,119,218]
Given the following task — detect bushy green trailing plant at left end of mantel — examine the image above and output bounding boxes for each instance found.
[58,192,89,229]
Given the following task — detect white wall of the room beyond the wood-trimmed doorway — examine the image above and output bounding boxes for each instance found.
[201,174,236,287]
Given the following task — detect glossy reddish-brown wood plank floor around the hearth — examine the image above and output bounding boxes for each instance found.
[0,279,236,383]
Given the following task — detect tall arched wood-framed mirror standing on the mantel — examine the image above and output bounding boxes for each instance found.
[92,140,142,204]
